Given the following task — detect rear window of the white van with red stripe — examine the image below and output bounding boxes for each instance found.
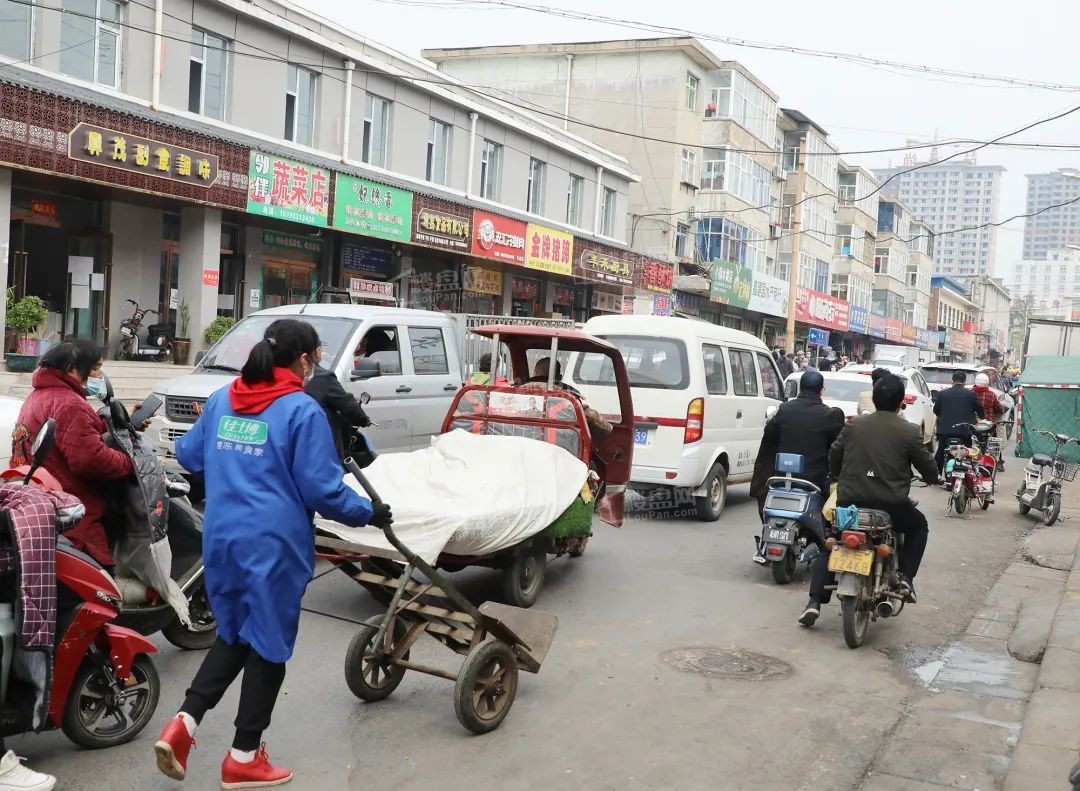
[573,335,690,390]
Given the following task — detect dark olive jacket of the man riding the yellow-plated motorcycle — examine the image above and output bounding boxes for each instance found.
[828,412,937,507]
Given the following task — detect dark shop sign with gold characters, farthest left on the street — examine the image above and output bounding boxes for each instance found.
[68,122,220,190]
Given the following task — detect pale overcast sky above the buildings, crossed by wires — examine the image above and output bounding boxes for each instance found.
[301,0,1080,282]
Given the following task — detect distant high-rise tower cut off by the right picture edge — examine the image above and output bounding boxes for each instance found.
[1024,167,1080,260]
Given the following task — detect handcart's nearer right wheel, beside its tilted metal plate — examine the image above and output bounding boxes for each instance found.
[454,640,517,734]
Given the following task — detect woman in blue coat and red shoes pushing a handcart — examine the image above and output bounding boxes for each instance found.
[154,319,391,789]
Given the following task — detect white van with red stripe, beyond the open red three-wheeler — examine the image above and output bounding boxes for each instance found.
[564,316,784,521]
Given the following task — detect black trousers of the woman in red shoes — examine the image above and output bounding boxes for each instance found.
[180,638,285,752]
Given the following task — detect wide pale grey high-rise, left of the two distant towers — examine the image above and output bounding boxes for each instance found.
[874,160,1004,276]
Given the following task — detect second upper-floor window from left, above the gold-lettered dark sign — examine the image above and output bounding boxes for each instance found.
[60,0,121,88]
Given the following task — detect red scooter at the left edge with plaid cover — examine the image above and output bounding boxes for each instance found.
[0,419,161,748]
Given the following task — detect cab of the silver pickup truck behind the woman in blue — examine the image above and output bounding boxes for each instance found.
[146,304,463,471]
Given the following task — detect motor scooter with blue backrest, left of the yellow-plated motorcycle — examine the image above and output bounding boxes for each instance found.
[754,453,825,585]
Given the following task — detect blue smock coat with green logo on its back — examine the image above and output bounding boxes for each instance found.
[176,388,372,662]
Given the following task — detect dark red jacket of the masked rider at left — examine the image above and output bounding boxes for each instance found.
[11,368,134,566]
